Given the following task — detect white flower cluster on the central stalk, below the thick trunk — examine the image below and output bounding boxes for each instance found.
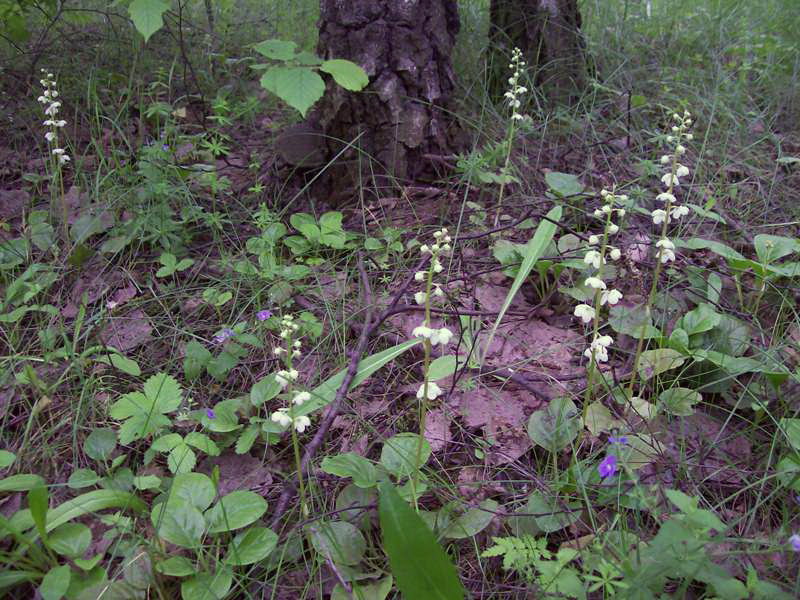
[411,228,453,400]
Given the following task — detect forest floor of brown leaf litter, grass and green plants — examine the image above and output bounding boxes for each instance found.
[0,2,800,600]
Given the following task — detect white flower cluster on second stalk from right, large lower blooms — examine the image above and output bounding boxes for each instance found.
[573,190,628,363]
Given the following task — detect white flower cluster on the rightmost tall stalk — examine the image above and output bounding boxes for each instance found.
[651,111,694,264]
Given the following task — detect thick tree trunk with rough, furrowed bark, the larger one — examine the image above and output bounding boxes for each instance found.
[314,0,460,202]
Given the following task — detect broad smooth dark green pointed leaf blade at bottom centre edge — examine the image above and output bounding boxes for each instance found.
[379,481,465,600]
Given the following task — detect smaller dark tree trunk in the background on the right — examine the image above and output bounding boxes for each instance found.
[489,0,586,102]
